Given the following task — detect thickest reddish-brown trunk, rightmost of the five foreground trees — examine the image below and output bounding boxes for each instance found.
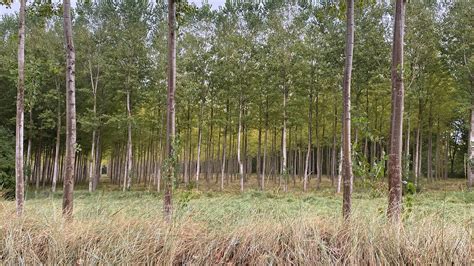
[387,0,405,222]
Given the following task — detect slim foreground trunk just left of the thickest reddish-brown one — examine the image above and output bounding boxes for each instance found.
[342,0,354,218]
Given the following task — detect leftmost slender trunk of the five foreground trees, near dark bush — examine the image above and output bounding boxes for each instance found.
[15,0,26,216]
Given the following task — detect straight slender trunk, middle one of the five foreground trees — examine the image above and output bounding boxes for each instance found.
[163,0,176,222]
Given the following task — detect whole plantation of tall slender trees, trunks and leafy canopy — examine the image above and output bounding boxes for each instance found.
[0,0,474,220]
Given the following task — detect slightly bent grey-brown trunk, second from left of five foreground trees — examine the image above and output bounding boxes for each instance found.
[63,0,76,219]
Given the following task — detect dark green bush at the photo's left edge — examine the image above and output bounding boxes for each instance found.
[0,126,15,198]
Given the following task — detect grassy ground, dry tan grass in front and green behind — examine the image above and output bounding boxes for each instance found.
[0,177,474,265]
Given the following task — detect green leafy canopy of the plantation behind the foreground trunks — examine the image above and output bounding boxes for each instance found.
[0,0,468,191]
